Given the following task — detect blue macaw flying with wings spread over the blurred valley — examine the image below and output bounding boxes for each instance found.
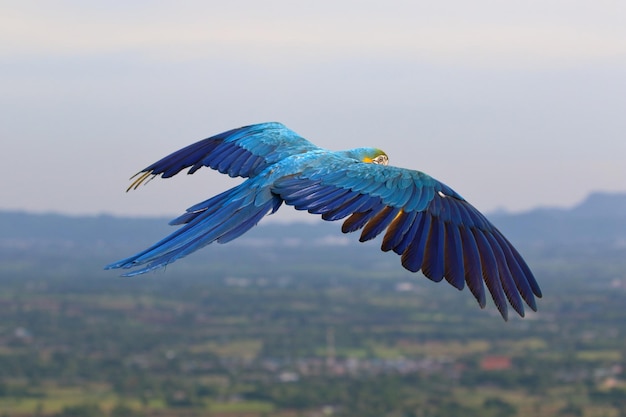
[106,122,541,320]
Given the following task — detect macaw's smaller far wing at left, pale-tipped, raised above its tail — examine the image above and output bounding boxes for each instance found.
[128,122,319,190]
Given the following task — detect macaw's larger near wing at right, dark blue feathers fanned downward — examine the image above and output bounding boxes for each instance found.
[272,157,541,320]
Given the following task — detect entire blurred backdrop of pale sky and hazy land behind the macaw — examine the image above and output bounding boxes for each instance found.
[0,0,626,417]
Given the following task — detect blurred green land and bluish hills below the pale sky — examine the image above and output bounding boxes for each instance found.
[0,191,626,417]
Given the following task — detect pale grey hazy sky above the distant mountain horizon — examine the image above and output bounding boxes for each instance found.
[0,0,626,218]
